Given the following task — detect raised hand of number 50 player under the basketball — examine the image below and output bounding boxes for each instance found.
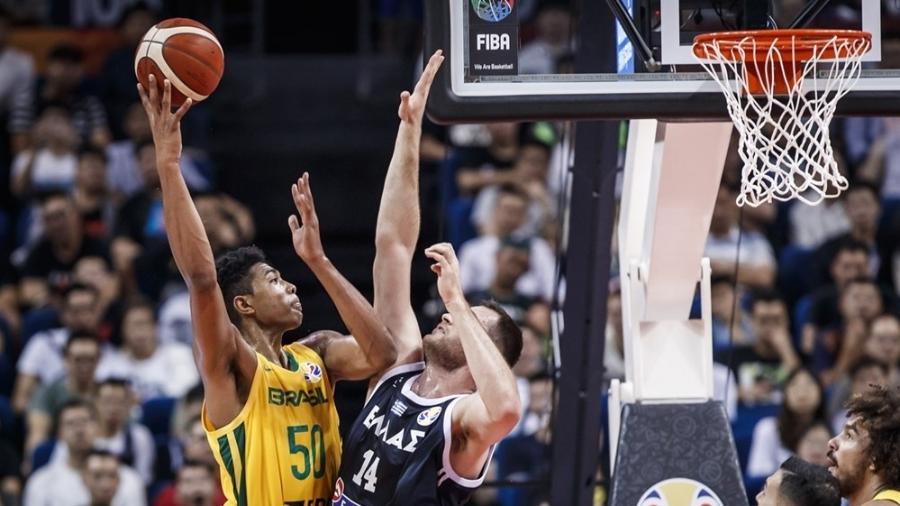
[138,74,192,167]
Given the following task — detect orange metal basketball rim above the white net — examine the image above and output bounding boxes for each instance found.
[694,28,872,62]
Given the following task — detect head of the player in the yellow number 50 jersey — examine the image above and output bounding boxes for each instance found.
[216,246,303,332]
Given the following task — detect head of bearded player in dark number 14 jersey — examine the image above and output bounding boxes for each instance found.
[423,301,522,371]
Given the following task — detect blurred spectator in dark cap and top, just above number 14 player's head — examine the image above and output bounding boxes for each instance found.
[466,237,550,335]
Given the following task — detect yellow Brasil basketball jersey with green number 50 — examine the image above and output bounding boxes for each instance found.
[202,343,341,506]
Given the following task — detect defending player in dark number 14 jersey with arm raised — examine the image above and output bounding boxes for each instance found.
[334,52,522,506]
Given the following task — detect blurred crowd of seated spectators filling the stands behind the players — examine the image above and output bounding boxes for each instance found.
[0,1,900,506]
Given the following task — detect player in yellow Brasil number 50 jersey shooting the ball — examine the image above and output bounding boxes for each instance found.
[138,77,396,506]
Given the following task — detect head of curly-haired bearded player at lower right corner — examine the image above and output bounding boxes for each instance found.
[828,386,900,497]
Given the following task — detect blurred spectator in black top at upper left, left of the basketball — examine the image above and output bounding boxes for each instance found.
[34,44,111,148]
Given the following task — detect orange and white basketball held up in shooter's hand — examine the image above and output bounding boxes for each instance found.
[134,18,225,107]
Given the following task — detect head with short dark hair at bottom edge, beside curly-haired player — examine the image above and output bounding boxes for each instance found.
[756,457,841,506]
